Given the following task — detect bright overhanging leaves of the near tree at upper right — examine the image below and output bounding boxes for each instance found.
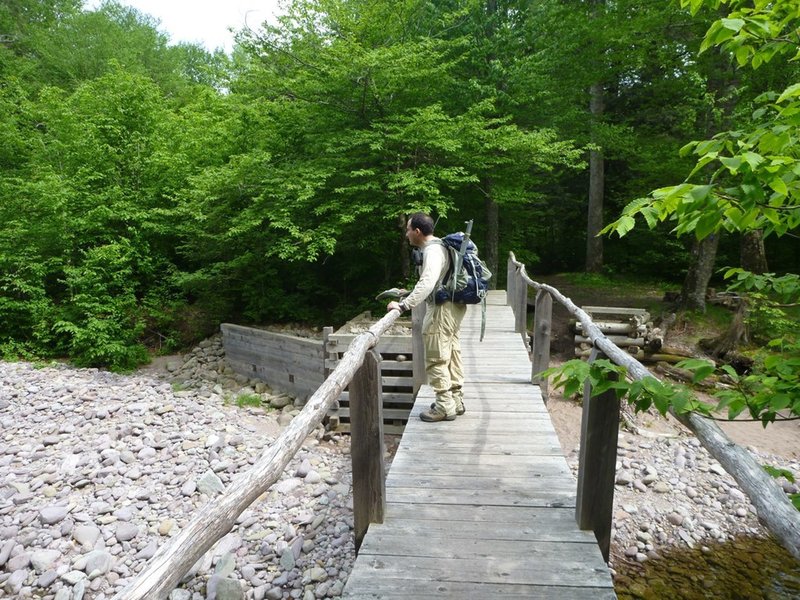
[604,0,800,244]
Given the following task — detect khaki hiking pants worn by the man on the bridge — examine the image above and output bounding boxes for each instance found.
[422,302,467,415]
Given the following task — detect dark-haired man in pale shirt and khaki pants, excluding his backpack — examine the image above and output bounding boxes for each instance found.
[386,213,467,422]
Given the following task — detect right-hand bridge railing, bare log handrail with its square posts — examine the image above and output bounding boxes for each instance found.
[507,252,800,560]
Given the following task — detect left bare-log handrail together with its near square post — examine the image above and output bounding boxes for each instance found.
[113,310,400,600]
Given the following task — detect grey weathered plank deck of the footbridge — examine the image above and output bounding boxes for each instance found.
[344,292,616,600]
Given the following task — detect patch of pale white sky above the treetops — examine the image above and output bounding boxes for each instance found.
[85,0,278,52]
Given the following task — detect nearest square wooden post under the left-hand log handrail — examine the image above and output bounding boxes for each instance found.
[349,348,386,552]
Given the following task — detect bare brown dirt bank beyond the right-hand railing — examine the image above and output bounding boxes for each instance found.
[538,276,800,460]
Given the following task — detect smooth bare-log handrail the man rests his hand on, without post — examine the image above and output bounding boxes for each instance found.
[113,310,400,600]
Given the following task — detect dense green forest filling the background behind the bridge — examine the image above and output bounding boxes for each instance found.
[0,0,800,369]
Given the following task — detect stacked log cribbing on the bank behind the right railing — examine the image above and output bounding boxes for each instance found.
[572,306,686,363]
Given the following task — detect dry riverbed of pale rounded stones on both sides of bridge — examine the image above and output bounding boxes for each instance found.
[0,337,800,600]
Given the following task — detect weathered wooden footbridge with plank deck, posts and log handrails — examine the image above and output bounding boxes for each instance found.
[113,254,800,600]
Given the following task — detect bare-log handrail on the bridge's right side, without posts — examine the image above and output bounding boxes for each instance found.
[520,278,800,560]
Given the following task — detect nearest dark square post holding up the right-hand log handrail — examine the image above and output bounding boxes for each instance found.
[575,348,620,562]
